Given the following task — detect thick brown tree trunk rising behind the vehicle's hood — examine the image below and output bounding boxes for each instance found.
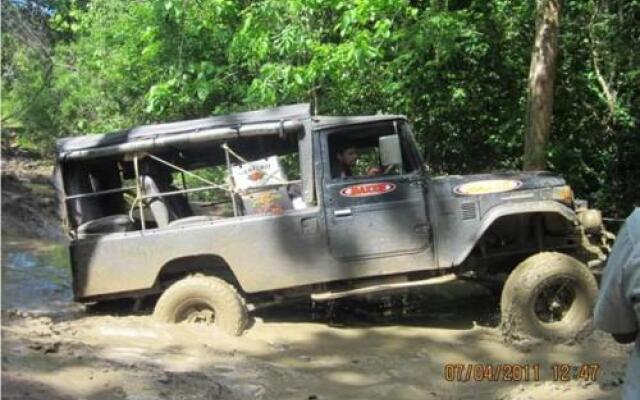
[524,0,560,170]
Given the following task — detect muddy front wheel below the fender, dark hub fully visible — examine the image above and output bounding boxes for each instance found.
[500,252,598,340]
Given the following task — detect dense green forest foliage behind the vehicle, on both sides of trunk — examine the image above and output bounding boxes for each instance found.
[2,0,640,215]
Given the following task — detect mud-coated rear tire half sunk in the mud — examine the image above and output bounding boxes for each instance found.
[153,275,248,336]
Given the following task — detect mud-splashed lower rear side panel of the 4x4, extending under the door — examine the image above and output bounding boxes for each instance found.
[72,208,433,298]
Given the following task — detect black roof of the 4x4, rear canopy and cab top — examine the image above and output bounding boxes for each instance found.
[56,103,405,157]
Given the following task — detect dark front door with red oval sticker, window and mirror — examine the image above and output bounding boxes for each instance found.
[321,120,431,261]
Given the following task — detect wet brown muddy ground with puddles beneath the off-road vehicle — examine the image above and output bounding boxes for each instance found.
[2,152,630,400]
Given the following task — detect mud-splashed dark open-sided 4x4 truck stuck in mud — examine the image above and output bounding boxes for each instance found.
[55,104,612,339]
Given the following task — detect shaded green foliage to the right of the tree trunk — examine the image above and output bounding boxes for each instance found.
[549,0,640,216]
